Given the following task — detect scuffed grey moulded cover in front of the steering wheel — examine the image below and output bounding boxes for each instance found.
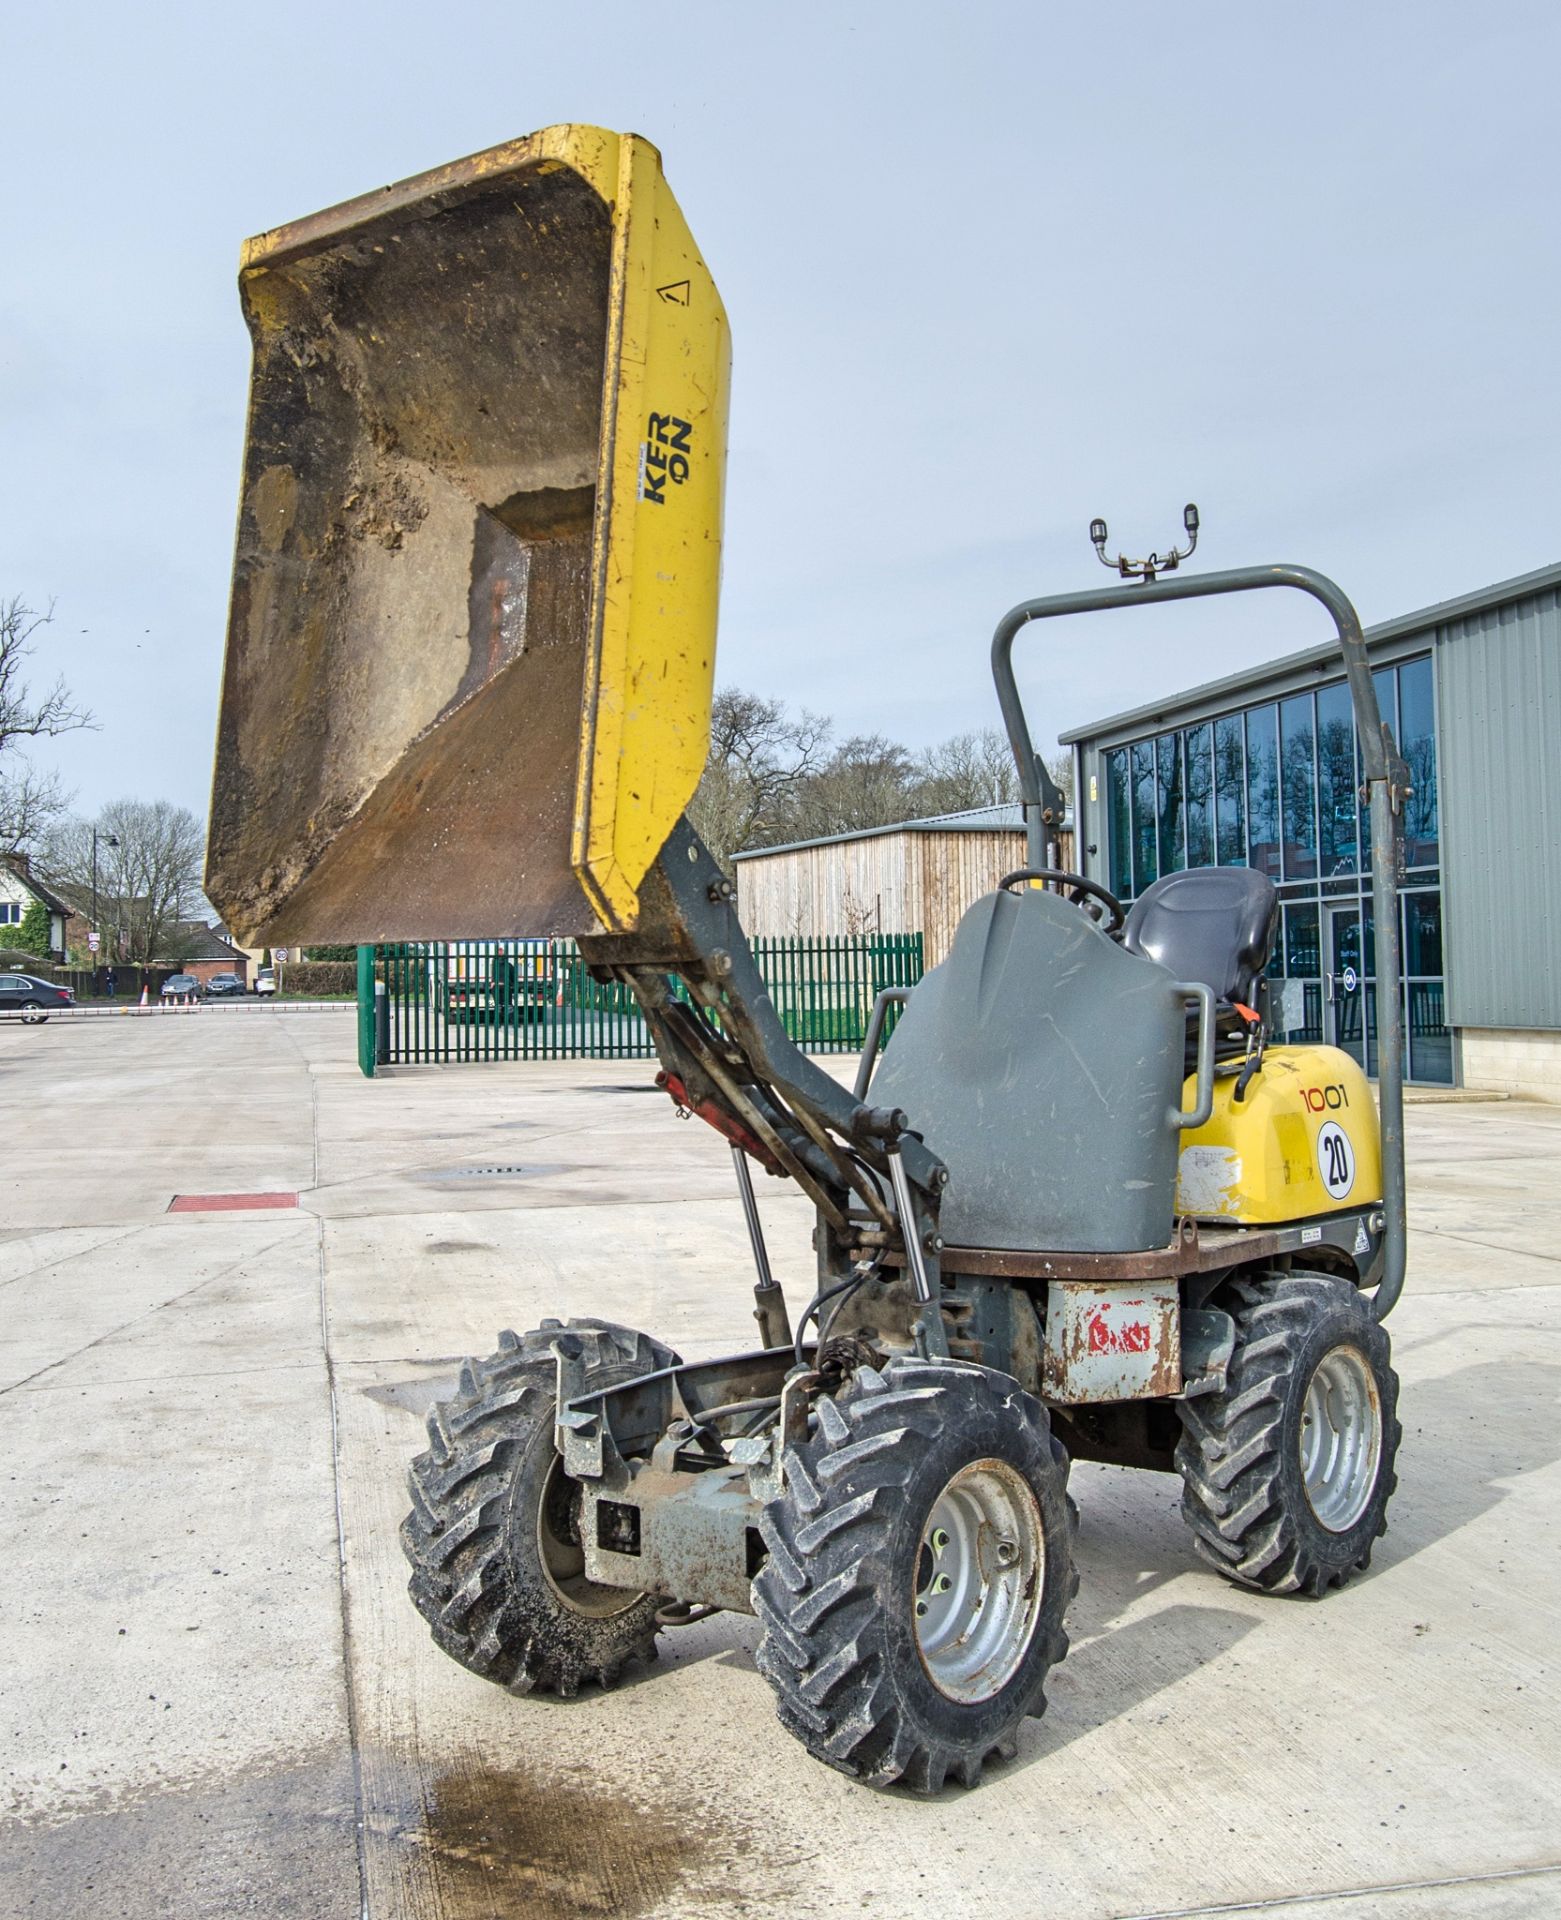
[870,889,1187,1252]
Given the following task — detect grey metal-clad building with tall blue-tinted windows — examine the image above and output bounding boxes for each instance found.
[1064,564,1561,1098]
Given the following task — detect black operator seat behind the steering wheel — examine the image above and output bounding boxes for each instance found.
[1121,866,1279,1071]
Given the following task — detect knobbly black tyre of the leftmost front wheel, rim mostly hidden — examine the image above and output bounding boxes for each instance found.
[401,1319,678,1695]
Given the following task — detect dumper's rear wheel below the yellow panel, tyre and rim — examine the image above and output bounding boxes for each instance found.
[1177,1273,1402,1597]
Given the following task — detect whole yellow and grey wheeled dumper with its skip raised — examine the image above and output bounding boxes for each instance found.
[207,127,1405,1793]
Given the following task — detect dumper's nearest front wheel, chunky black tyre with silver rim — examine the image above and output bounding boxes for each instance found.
[753,1359,1079,1793]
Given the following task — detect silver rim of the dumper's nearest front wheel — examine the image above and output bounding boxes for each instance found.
[914,1459,1046,1703]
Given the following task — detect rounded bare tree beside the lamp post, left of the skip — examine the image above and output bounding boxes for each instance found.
[40,801,205,966]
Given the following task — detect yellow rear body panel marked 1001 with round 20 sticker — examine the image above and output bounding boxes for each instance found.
[1177,1046,1382,1227]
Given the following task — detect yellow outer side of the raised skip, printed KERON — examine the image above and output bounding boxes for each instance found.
[568,134,732,931]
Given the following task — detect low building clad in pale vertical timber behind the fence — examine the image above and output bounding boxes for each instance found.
[735,806,1071,966]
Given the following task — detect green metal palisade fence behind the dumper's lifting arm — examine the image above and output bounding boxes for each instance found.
[357,933,922,1073]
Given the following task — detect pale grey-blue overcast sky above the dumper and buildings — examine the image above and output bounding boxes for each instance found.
[0,0,1561,810]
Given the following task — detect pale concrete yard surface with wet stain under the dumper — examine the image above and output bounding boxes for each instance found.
[0,1014,1561,1920]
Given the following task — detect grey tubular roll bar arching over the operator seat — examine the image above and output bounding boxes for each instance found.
[993,566,1409,1321]
